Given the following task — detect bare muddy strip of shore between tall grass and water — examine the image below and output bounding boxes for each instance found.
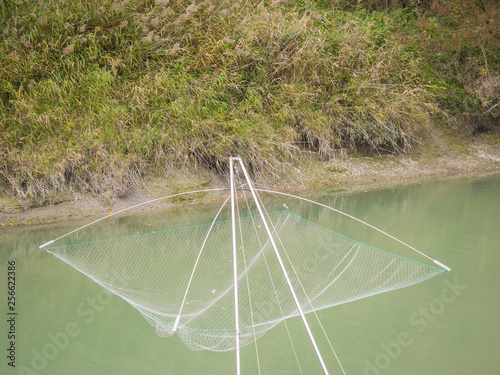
[0,133,500,228]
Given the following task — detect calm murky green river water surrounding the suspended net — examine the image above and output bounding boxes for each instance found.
[0,175,500,375]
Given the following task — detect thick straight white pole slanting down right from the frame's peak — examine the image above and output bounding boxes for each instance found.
[235,158,328,375]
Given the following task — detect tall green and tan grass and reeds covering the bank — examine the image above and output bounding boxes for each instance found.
[0,0,500,209]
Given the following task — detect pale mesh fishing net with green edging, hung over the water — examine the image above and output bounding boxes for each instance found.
[42,210,444,351]
